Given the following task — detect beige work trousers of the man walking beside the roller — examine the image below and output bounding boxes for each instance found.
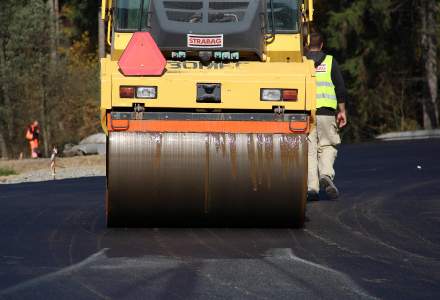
[308,116,341,192]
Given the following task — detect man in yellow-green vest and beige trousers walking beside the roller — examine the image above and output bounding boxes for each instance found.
[306,33,347,201]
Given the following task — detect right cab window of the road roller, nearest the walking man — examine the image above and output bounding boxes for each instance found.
[266,0,300,33]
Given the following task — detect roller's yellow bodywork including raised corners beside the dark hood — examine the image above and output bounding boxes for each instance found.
[101,33,316,131]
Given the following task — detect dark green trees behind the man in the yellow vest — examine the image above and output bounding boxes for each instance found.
[317,0,434,141]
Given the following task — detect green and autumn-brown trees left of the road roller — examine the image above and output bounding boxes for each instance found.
[0,0,99,157]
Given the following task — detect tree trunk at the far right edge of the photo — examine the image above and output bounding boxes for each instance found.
[419,0,439,129]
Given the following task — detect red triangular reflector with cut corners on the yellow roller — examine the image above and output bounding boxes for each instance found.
[118,32,167,76]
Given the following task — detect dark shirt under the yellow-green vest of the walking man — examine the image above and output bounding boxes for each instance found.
[306,51,348,116]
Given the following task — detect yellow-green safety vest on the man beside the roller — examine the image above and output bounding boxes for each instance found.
[316,55,338,109]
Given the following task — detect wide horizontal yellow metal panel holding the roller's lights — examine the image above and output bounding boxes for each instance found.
[102,61,316,111]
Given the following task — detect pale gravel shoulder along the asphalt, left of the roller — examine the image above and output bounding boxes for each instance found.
[0,155,105,184]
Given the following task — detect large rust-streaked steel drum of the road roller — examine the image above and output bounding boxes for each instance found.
[107,132,307,226]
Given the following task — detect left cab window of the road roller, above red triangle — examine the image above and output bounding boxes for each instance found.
[115,0,150,32]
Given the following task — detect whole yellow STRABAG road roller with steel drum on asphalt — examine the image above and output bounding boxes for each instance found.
[101,0,316,227]
